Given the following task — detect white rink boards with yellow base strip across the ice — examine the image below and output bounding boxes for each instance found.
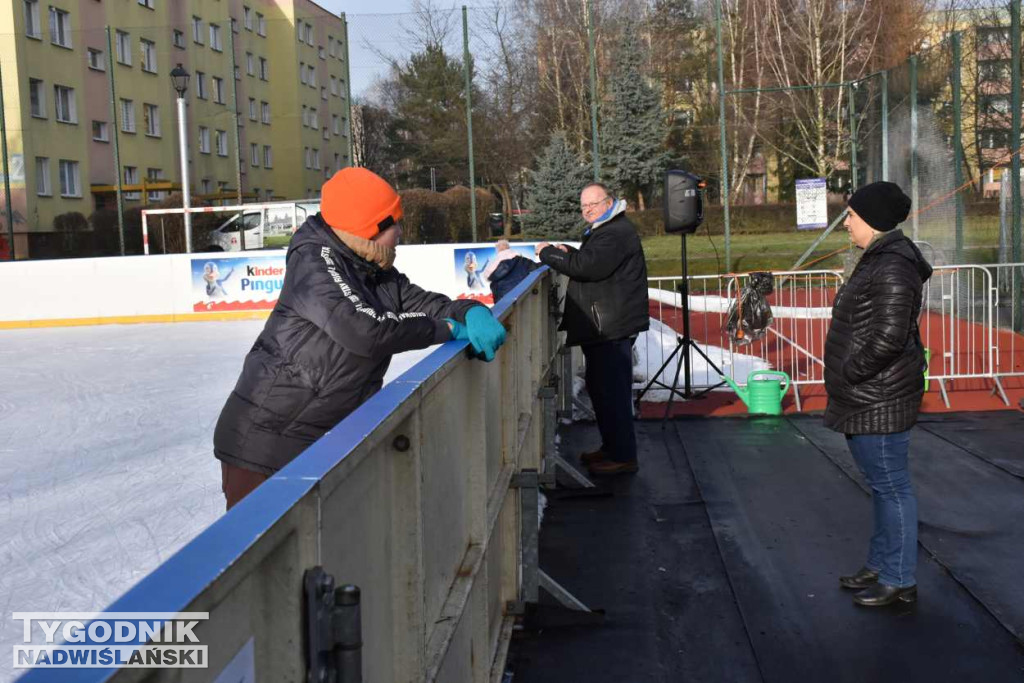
[0,243,552,327]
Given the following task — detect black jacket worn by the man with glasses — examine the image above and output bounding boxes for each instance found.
[540,212,650,346]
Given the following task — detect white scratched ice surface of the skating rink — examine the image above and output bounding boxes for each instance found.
[0,321,429,682]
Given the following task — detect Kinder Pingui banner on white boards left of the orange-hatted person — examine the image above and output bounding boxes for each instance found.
[190,254,285,312]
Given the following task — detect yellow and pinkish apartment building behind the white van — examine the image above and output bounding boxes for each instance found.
[0,0,350,253]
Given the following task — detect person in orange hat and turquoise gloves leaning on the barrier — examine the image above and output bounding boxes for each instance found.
[213,168,505,509]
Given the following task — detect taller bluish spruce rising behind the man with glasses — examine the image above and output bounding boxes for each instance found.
[601,22,669,208]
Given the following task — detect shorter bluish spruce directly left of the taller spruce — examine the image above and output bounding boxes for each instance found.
[523,130,590,240]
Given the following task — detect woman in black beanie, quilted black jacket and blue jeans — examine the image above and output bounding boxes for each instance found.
[824,182,932,606]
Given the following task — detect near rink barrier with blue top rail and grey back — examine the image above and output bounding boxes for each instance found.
[14,268,559,683]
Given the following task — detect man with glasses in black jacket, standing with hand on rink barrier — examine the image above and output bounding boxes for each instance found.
[537,182,650,475]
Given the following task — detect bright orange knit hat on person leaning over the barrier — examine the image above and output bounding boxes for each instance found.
[321,167,402,240]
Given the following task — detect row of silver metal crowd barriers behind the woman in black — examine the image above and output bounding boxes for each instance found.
[644,264,1024,410]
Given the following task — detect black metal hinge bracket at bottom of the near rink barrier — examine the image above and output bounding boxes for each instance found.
[302,566,362,683]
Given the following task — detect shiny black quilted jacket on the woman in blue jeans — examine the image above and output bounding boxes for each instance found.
[824,230,932,434]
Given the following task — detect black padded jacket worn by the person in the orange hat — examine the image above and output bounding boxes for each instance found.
[213,214,478,474]
